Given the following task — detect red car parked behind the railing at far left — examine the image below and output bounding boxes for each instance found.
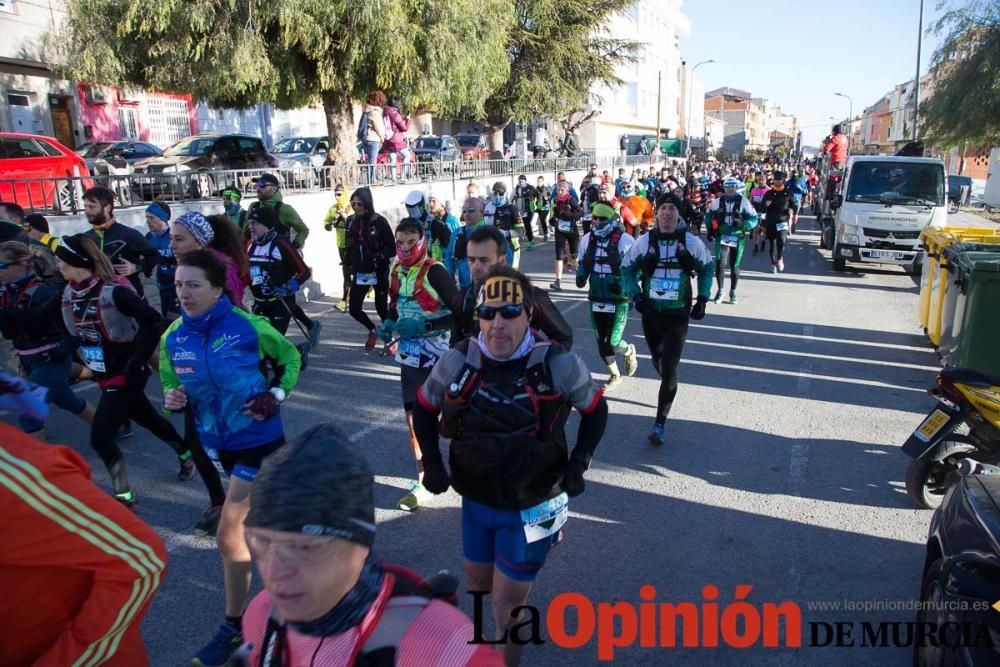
[0,132,93,212]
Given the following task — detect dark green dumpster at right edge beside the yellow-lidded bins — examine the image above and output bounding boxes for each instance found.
[945,251,1000,377]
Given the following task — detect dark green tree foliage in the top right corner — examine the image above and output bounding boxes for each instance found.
[920,0,1000,148]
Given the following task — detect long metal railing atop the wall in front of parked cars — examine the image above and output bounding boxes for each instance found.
[0,151,683,214]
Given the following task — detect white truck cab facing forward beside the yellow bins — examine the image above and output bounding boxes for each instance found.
[829,155,948,273]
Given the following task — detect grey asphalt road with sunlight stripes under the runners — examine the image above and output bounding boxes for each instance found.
[37,211,937,666]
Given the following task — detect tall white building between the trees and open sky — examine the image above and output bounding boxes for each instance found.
[578,0,694,151]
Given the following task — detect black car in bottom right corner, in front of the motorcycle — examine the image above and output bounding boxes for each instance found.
[913,461,1000,665]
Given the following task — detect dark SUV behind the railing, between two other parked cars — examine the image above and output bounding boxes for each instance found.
[132,134,278,199]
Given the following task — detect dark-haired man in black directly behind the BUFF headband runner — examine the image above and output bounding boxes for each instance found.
[451,225,573,350]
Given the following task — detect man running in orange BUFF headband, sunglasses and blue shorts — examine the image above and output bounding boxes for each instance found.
[413,266,608,665]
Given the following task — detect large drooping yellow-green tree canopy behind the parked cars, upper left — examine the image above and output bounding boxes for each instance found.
[56,0,513,162]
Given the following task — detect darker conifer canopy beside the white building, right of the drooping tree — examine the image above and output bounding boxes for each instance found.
[486,0,638,146]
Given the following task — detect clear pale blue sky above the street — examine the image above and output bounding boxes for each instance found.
[680,0,941,146]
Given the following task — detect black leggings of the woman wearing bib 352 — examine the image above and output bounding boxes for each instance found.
[90,380,187,494]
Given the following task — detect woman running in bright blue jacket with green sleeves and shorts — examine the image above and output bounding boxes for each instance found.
[160,250,299,665]
